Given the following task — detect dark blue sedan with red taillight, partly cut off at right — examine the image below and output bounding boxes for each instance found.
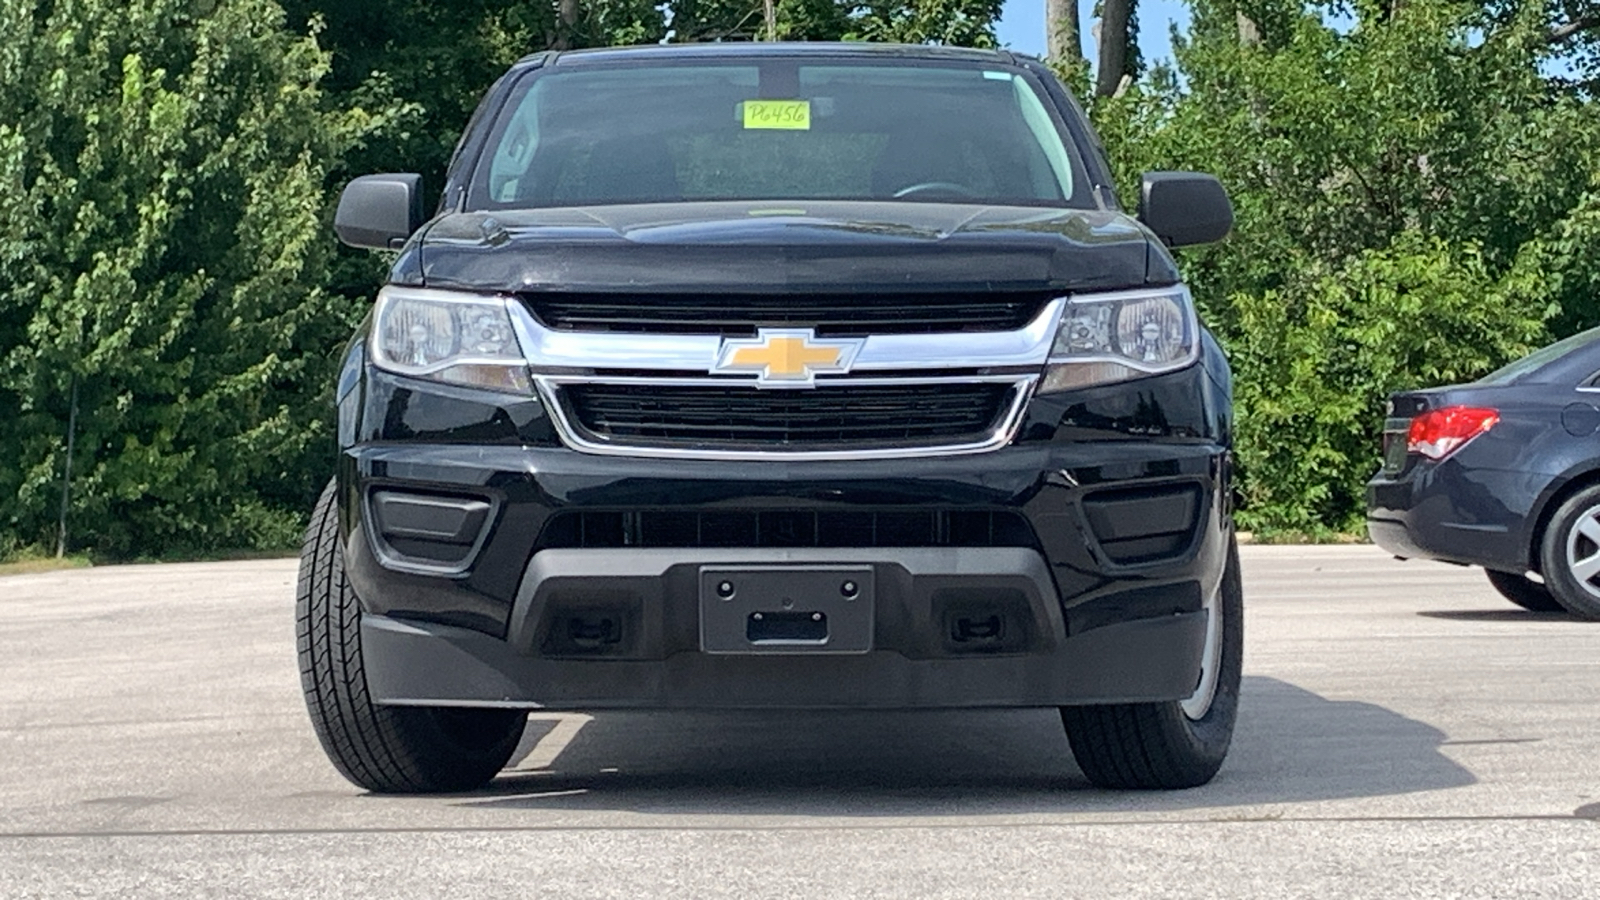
[1366,328,1600,621]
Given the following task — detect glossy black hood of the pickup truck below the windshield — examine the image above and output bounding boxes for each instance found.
[403,200,1178,291]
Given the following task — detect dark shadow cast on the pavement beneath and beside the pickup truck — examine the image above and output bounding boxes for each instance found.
[456,677,1475,817]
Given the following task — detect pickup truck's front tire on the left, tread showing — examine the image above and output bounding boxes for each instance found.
[294,484,528,793]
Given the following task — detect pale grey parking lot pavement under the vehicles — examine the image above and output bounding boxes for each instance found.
[0,546,1600,898]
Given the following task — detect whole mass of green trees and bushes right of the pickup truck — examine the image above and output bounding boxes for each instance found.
[1093,0,1600,530]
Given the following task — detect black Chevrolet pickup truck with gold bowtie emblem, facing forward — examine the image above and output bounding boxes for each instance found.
[298,43,1243,791]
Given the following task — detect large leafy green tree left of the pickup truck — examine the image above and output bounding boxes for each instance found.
[0,0,396,556]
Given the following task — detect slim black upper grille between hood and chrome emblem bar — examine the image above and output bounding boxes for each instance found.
[525,291,1051,336]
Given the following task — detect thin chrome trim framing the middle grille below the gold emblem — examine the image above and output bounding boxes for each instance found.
[534,375,1038,461]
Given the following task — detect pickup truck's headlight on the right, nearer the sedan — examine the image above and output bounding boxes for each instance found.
[1038,285,1200,392]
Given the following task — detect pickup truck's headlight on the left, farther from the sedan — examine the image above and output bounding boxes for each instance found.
[371,285,530,394]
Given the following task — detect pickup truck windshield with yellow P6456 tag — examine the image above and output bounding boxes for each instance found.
[469,59,1091,210]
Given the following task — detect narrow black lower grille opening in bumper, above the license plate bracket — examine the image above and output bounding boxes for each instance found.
[538,509,1037,549]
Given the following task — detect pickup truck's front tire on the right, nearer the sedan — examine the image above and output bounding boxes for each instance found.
[1061,536,1245,790]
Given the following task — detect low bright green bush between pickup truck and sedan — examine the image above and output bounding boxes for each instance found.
[1229,232,1542,533]
